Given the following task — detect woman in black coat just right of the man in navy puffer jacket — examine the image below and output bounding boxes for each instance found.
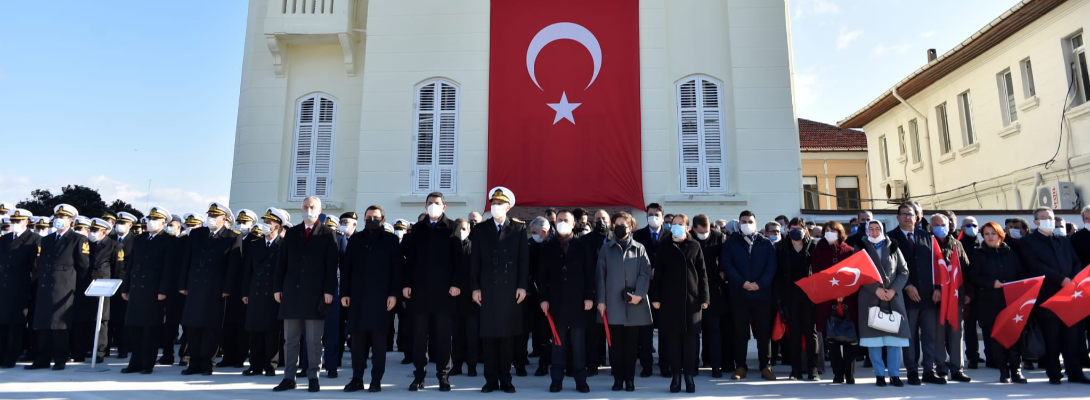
[776,217,823,380]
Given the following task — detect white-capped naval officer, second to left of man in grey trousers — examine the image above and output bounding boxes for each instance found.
[178,202,241,376]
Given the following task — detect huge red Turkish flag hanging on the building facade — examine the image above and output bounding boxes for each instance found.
[488,0,643,209]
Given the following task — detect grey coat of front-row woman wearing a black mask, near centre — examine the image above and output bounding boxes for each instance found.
[596,240,651,326]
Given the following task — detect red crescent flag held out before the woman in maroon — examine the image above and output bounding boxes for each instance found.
[795,252,882,304]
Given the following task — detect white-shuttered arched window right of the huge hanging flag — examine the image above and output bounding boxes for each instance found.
[677,76,727,193]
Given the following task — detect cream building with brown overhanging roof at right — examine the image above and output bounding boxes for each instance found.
[839,0,1090,210]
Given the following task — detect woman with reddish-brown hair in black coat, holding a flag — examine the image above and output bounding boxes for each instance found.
[969,222,1027,384]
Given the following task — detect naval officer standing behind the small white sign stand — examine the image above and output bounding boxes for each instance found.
[72,218,119,363]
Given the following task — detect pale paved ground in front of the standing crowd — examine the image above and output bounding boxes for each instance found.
[0,353,1090,400]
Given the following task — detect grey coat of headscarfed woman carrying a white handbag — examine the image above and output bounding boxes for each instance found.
[859,238,909,339]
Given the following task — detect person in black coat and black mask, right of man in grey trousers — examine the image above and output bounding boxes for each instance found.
[340,210,403,391]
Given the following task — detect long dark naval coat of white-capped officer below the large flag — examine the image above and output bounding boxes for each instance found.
[470,218,530,338]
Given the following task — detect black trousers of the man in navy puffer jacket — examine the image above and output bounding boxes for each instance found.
[731,299,775,369]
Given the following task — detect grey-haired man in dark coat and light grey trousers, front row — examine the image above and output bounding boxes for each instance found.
[273,196,340,392]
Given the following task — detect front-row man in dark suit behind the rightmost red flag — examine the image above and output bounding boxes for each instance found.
[1021,207,1090,385]
